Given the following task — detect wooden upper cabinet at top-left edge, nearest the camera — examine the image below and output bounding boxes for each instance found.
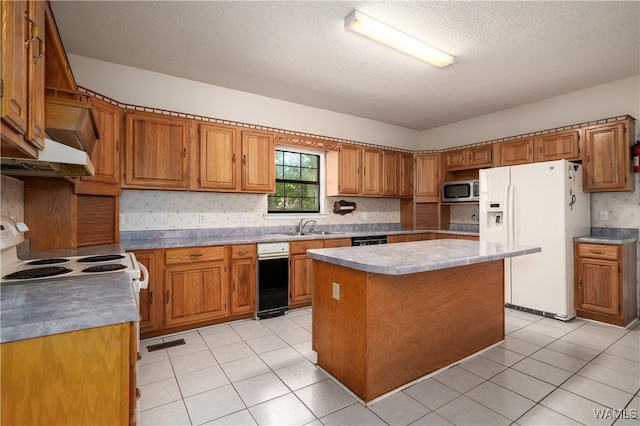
[1,0,46,158]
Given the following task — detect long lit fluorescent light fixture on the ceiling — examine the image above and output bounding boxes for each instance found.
[344,10,454,68]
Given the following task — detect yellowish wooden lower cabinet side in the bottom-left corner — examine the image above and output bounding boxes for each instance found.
[0,323,137,425]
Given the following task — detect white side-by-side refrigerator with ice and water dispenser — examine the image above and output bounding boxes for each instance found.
[479,160,590,321]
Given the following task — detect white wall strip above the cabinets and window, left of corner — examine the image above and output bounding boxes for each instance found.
[68,55,419,150]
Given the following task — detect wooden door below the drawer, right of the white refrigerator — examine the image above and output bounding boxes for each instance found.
[576,257,620,317]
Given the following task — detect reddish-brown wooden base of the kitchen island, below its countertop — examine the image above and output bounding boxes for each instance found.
[312,260,504,402]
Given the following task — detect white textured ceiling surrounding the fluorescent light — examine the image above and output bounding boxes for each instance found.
[52,1,640,130]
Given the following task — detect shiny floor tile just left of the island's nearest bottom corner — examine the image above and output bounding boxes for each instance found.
[295,379,356,418]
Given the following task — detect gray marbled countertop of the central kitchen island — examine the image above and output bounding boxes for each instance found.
[307,239,542,275]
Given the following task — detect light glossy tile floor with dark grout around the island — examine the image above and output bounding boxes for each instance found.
[139,309,640,426]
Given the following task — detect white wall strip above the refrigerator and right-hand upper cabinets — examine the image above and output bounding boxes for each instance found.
[419,76,640,150]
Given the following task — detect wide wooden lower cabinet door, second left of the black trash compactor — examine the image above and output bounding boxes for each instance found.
[164,262,229,326]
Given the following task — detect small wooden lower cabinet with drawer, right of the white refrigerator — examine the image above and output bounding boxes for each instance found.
[575,243,637,327]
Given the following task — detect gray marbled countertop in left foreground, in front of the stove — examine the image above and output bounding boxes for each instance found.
[0,274,139,343]
